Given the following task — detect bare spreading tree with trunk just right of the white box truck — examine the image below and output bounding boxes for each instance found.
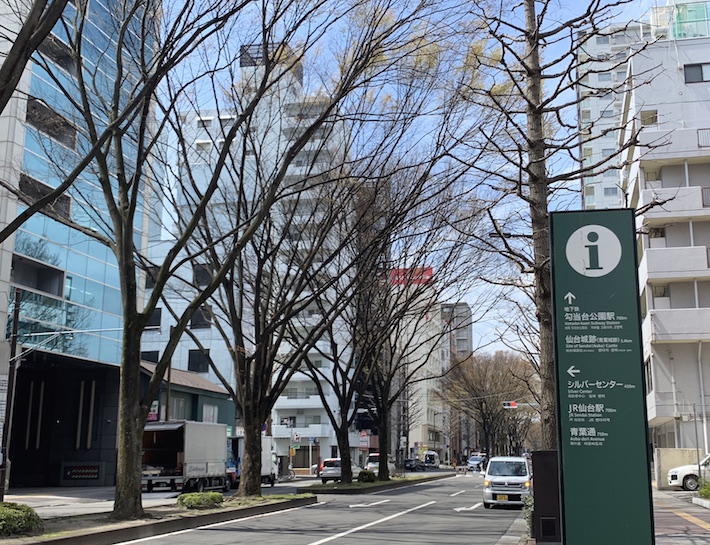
[149,2,490,495]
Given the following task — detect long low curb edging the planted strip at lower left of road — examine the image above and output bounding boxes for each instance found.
[12,496,318,545]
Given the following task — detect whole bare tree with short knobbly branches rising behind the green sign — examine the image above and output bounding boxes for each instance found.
[460,0,652,449]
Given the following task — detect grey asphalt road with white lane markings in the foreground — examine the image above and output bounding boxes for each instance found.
[114,475,520,545]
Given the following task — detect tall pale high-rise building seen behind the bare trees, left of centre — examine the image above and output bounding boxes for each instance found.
[142,45,358,467]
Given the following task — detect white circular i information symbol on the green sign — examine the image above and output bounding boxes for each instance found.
[565,225,621,278]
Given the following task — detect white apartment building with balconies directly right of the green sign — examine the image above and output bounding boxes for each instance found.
[620,25,710,452]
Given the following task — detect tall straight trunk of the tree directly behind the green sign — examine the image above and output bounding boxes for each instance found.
[525,0,557,450]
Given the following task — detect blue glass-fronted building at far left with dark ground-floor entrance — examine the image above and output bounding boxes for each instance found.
[0,0,152,487]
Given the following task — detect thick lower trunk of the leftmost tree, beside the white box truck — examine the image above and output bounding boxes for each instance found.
[112,327,147,520]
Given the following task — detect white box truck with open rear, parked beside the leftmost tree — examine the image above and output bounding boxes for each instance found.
[141,420,232,492]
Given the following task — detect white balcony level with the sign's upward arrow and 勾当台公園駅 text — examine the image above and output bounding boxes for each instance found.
[641,308,710,343]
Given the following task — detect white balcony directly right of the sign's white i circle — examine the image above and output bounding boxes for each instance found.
[639,246,710,285]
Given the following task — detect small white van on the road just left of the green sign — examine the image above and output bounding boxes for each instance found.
[483,456,532,509]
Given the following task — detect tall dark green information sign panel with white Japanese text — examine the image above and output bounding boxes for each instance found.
[550,210,654,545]
